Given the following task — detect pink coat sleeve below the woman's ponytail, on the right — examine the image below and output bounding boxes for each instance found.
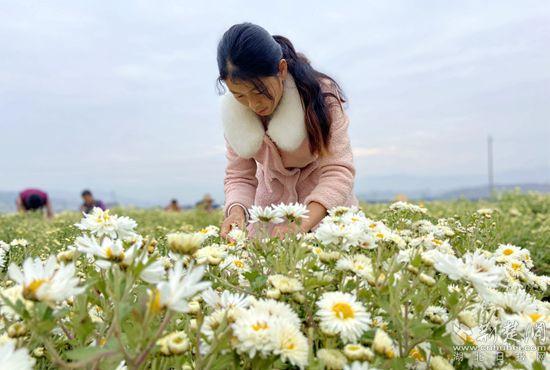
[304,82,355,210]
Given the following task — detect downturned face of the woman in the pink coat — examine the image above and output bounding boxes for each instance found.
[225,59,287,116]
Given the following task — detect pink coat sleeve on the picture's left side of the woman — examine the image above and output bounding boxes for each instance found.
[224,140,258,216]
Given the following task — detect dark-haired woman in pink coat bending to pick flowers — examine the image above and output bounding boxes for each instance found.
[218,23,358,237]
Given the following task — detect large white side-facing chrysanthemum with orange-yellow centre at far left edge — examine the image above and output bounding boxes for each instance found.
[8,256,84,304]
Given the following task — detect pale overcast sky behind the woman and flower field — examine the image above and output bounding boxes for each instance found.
[0,0,550,202]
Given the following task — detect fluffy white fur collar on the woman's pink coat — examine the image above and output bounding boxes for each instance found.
[221,73,307,158]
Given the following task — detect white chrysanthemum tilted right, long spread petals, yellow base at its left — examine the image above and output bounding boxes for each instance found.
[149,263,210,312]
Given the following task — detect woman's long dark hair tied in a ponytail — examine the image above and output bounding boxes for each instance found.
[217,22,346,156]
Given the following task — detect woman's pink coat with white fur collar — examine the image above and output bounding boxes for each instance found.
[222,74,358,230]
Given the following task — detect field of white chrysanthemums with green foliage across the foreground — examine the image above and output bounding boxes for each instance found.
[0,193,550,370]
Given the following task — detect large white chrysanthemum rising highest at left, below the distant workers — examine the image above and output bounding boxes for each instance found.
[75,207,137,240]
